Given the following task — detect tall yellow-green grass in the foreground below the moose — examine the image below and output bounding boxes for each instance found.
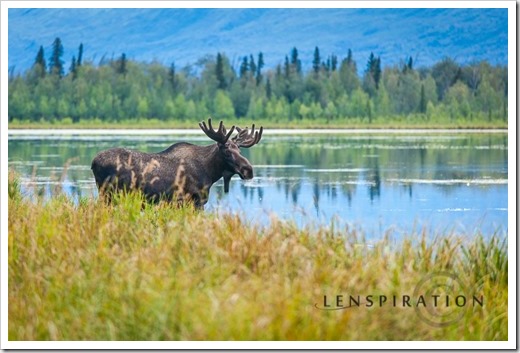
[8,172,508,340]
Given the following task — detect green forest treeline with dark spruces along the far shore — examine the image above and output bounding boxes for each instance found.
[9,38,508,124]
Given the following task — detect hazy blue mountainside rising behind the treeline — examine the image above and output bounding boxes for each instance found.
[8,8,508,72]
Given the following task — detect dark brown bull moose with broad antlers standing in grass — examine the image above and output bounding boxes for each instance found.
[91,119,263,208]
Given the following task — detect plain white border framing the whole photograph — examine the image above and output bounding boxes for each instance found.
[0,0,517,350]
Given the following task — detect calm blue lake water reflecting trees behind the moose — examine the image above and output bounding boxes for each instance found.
[8,131,508,238]
